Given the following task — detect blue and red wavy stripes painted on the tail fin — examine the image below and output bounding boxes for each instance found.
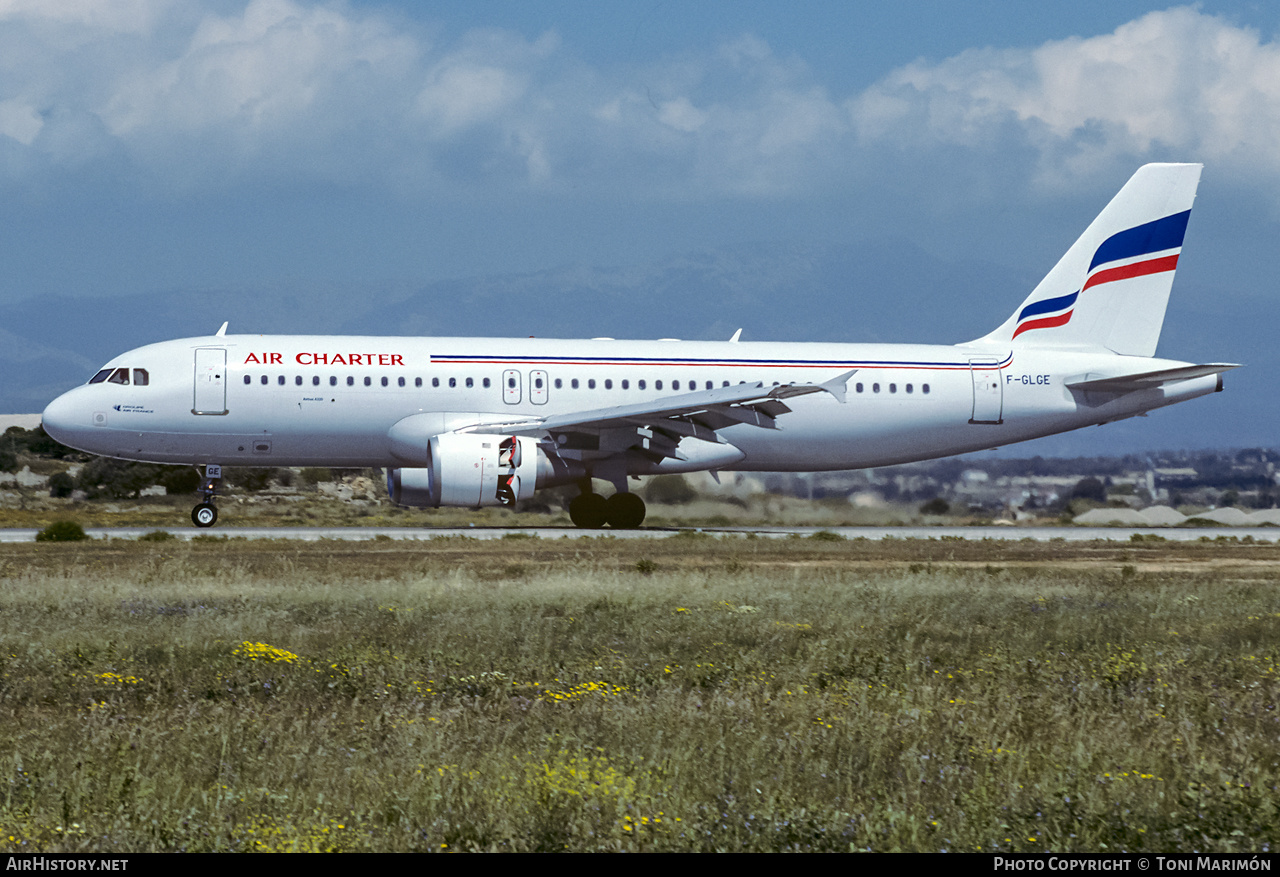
[1014,210,1192,338]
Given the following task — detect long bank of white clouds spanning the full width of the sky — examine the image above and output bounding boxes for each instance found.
[0,0,1280,198]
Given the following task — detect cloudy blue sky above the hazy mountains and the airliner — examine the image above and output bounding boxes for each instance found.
[0,0,1280,448]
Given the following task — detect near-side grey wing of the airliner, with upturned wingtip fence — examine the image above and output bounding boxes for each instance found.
[460,369,856,458]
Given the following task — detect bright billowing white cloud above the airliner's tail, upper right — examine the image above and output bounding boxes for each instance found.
[850,8,1280,185]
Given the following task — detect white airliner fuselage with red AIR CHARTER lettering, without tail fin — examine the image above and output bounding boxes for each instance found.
[45,335,1220,471]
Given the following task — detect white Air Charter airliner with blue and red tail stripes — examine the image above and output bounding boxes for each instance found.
[44,164,1235,527]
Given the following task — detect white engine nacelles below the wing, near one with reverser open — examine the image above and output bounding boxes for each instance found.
[387,433,538,508]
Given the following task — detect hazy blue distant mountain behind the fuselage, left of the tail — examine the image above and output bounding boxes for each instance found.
[342,242,1025,343]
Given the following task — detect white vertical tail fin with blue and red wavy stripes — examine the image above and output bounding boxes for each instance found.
[978,164,1202,356]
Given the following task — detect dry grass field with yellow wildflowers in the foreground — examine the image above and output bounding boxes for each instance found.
[0,534,1280,851]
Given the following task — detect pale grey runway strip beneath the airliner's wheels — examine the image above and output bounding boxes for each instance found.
[0,526,1280,543]
